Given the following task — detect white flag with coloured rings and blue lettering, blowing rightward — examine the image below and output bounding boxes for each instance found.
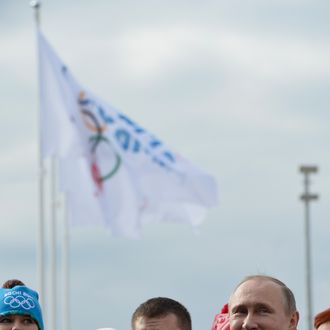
[38,32,217,237]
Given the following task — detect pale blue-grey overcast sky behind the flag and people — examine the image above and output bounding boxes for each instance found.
[0,0,330,330]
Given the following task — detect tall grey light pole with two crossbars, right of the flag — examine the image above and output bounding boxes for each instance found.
[300,166,319,329]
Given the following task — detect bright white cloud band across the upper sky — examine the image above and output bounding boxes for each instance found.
[43,24,330,94]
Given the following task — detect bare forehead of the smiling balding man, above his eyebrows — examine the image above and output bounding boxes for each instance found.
[229,278,284,307]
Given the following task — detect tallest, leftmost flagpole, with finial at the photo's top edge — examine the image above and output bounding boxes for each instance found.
[30,1,45,305]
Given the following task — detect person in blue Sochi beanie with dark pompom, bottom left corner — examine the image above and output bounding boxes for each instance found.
[0,280,44,330]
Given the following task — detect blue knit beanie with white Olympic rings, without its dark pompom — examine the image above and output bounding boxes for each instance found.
[0,285,44,330]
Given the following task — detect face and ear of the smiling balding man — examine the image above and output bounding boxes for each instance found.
[229,279,299,330]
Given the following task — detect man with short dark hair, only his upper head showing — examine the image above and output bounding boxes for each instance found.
[131,297,192,330]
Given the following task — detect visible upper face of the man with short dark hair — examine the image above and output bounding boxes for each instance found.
[133,313,182,330]
